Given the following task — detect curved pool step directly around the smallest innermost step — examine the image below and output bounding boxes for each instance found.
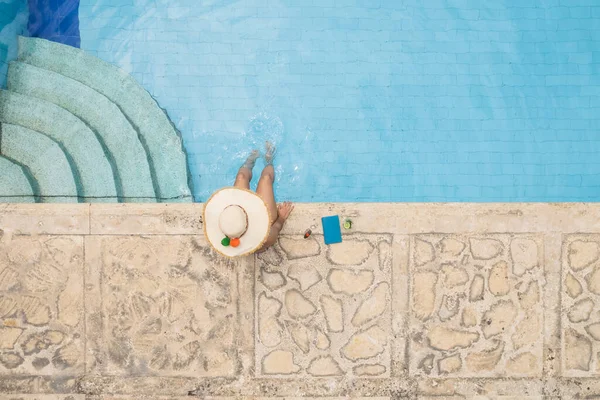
[0,124,78,203]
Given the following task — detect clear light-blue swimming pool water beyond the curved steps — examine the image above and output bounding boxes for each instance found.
[0,0,600,202]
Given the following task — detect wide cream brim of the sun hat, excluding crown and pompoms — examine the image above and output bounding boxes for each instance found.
[203,187,271,257]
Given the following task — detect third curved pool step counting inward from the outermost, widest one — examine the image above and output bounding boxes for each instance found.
[0,90,118,203]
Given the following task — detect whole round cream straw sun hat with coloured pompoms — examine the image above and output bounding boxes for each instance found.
[204,187,271,257]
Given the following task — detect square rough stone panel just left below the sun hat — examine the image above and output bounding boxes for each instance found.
[86,236,238,377]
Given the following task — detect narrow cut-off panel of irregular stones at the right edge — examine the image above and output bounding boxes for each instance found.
[560,234,600,377]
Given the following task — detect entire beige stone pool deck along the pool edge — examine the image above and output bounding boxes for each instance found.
[0,203,600,400]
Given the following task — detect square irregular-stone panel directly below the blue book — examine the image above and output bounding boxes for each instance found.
[255,234,392,378]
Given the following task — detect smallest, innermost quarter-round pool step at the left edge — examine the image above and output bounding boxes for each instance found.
[0,156,35,203]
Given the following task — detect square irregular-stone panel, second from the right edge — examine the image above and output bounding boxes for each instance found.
[409,233,544,378]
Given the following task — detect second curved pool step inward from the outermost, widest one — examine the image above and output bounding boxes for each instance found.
[8,62,156,202]
